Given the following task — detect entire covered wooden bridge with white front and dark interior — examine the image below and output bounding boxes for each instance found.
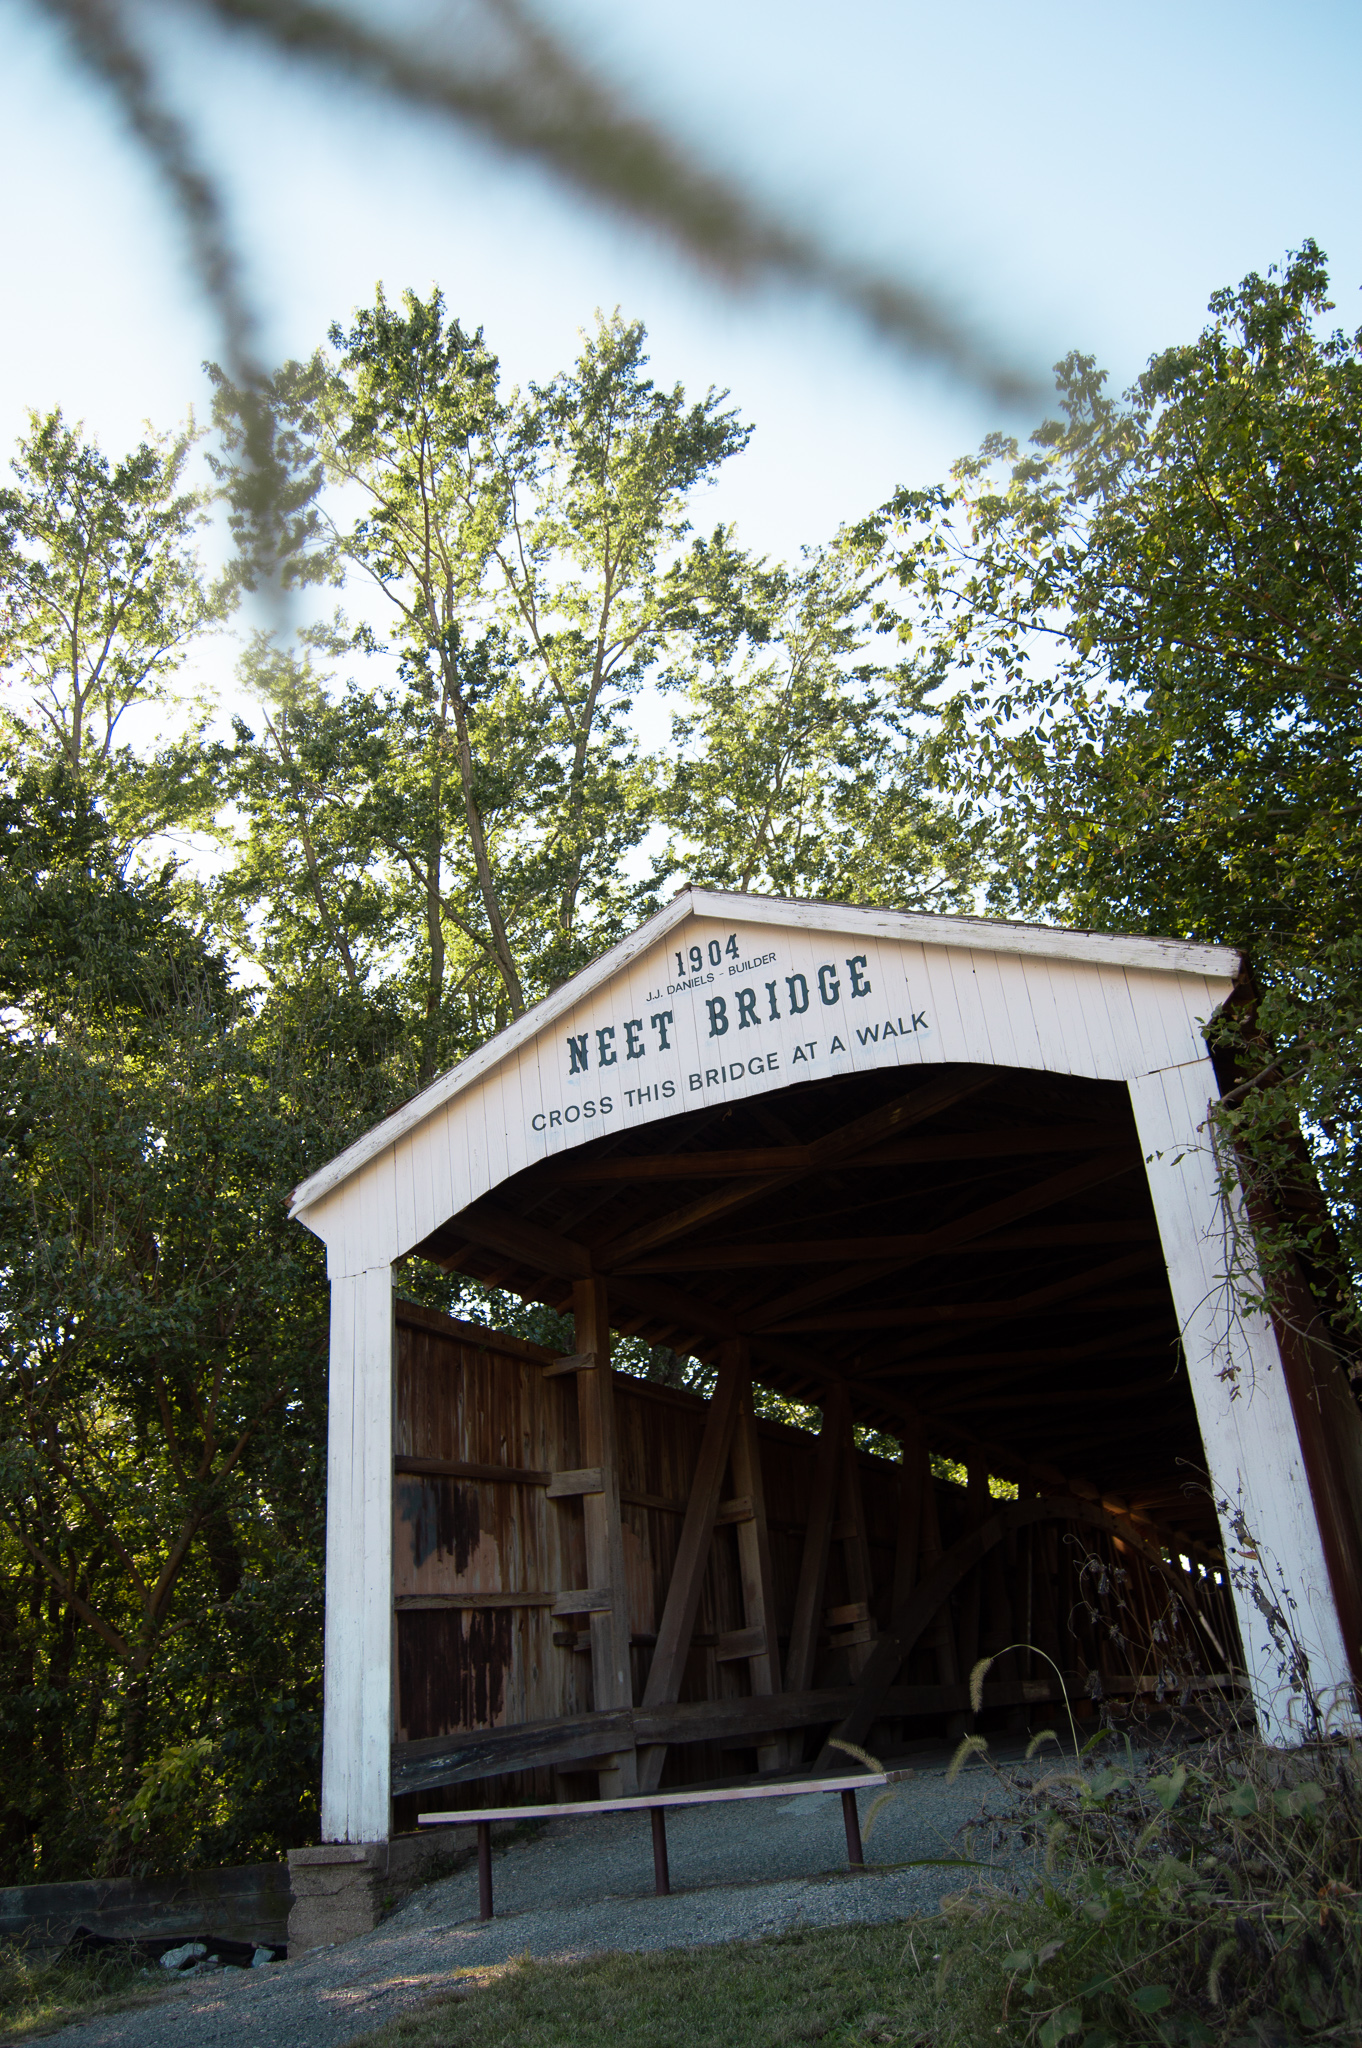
[293,889,1362,1843]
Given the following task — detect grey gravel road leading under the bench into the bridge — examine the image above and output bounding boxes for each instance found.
[49,1757,1040,2048]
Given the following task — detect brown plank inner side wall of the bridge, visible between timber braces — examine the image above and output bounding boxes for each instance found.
[393,1303,1235,1827]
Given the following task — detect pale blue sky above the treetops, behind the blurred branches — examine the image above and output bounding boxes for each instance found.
[0,0,1362,684]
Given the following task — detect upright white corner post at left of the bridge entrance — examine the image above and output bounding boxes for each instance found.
[322,1266,395,1843]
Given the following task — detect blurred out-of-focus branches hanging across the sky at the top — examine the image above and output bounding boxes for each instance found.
[33,0,1042,403]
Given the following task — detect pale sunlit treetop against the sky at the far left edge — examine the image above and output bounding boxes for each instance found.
[0,412,225,831]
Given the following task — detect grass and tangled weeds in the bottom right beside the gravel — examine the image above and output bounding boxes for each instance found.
[348,1731,1362,2048]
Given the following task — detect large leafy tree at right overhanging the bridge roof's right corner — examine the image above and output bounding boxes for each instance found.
[866,242,1362,1333]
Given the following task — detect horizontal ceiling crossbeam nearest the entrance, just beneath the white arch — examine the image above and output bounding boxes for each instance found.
[551,1124,1126,1186]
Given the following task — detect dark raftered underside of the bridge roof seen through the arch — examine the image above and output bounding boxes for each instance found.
[418,1065,1217,1554]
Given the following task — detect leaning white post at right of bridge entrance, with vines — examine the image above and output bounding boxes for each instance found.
[1131,1059,1358,1747]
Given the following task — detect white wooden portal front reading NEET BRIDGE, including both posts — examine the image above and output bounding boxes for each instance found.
[293,889,1352,1841]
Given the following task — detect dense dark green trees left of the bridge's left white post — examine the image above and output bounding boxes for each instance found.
[0,762,393,1876]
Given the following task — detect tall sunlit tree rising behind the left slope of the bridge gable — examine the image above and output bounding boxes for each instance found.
[219,293,746,1081]
